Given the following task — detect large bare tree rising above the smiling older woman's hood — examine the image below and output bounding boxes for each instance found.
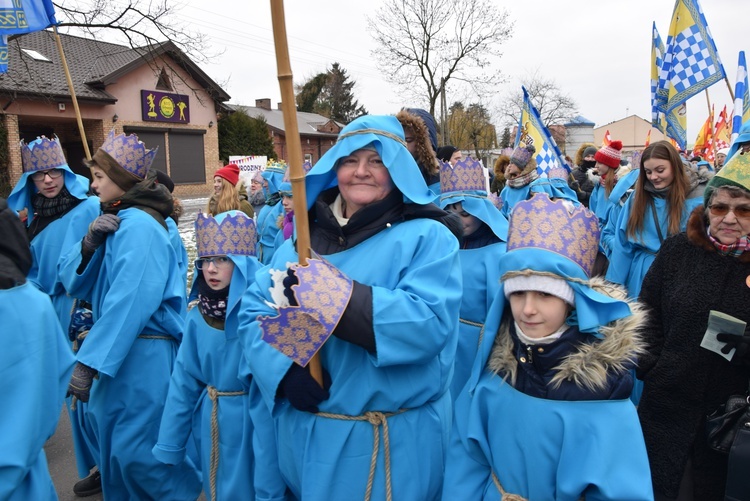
[368,0,513,116]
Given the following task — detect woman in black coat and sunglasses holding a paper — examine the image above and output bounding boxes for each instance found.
[638,150,750,500]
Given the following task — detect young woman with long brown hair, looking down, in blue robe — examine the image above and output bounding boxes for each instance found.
[606,141,708,298]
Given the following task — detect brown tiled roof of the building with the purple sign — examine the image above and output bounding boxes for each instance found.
[0,31,229,104]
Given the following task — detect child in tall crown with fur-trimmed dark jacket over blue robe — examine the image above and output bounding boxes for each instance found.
[443,193,653,500]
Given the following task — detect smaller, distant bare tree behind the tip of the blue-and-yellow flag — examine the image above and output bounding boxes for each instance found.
[499,72,578,127]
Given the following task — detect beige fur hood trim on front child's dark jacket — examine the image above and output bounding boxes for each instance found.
[487,277,646,391]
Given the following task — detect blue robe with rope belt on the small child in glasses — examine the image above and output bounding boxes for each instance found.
[153,211,260,499]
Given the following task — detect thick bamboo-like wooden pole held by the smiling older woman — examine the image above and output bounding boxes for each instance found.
[271,0,323,387]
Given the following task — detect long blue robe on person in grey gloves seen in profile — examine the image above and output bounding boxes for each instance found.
[60,207,200,500]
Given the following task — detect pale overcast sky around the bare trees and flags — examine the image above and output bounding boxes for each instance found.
[172,0,750,143]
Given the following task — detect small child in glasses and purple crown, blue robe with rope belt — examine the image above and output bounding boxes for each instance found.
[153,211,283,500]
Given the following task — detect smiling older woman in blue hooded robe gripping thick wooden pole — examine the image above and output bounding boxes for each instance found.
[239,116,461,499]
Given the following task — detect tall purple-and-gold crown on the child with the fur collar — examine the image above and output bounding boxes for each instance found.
[508,193,599,277]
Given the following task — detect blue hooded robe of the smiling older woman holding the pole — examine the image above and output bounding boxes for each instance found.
[239,116,461,500]
